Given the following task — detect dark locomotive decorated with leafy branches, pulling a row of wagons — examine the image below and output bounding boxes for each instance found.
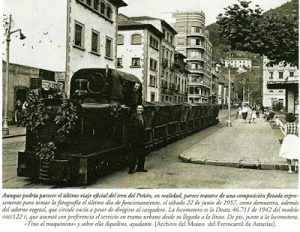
[17,68,219,185]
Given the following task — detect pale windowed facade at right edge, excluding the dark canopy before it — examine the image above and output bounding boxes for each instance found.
[263,57,299,107]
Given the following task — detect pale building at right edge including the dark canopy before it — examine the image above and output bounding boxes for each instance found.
[263,57,299,112]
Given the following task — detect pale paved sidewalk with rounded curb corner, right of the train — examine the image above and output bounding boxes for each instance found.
[179,118,287,170]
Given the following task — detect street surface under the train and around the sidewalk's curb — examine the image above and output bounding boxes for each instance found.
[3,113,298,189]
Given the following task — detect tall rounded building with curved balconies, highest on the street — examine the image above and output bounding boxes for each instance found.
[175,11,212,103]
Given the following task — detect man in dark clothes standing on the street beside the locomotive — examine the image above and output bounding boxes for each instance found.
[128,105,147,174]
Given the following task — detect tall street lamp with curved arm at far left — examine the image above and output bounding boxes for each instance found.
[2,15,26,135]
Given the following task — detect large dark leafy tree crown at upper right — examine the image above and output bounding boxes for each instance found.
[217,0,298,66]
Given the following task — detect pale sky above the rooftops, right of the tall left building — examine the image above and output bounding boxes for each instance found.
[120,0,290,25]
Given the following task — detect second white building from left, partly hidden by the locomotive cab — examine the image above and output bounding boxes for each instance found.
[117,14,163,101]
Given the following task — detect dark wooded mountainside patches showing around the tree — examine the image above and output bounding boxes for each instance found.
[206,0,299,63]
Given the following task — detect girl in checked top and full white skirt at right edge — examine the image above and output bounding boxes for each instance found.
[279,113,300,174]
